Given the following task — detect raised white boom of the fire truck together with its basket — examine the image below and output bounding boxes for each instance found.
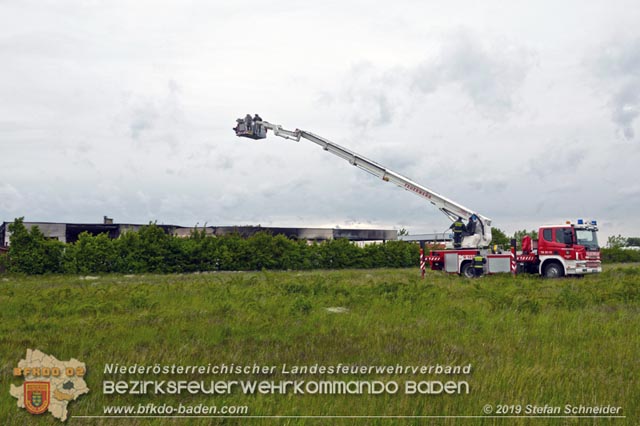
[233,115,491,249]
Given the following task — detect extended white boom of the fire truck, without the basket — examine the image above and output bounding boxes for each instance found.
[236,121,491,248]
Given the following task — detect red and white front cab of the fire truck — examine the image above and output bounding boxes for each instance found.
[534,219,602,278]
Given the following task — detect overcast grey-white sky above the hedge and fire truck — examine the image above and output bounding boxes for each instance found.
[0,0,640,238]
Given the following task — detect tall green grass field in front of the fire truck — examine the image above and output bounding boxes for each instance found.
[0,265,640,425]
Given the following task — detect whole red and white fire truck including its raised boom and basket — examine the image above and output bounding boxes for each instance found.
[233,115,602,278]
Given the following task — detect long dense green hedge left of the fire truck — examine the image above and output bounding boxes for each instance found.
[3,219,419,274]
